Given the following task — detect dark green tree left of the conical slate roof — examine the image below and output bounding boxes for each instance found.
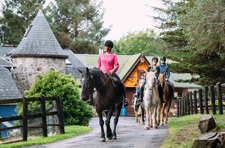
[0,0,45,46]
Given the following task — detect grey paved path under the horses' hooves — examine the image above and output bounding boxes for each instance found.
[26,117,169,148]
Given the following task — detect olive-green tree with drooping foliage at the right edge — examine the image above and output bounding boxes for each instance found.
[180,0,225,84]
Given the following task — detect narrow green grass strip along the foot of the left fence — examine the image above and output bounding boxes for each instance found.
[0,125,92,148]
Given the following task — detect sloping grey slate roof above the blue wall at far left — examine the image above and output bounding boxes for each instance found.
[0,66,21,100]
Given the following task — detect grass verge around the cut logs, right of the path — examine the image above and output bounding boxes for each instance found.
[160,111,225,148]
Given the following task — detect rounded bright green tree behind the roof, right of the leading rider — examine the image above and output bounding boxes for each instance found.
[113,29,167,55]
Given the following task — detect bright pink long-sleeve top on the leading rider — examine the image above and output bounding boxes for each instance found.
[97,53,119,73]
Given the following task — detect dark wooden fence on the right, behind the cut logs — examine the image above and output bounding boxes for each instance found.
[176,83,225,117]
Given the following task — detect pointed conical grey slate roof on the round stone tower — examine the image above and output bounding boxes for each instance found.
[12,10,68,59]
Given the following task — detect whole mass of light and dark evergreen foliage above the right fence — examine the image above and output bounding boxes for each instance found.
[155,0,225,85]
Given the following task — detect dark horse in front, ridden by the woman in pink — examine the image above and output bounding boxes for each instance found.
[78,68,125,142]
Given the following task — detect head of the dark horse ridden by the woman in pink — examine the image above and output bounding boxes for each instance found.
[78,67,94,101]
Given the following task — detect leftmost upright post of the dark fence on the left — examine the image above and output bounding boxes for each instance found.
[23,96,28,141]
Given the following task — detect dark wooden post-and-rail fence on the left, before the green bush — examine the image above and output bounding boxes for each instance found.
[0,95,65,143]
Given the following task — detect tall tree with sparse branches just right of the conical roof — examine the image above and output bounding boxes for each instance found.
[47,0,110,53]
